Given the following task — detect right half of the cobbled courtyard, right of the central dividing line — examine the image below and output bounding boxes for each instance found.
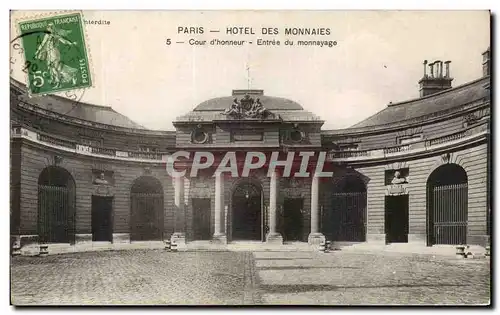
[255,251,490,305]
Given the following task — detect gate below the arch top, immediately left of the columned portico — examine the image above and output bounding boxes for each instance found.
[130,193,163,241]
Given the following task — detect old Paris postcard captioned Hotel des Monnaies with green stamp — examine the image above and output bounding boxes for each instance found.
[9,10,493,306]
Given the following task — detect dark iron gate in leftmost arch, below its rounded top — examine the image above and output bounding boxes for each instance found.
[38,185,74,243]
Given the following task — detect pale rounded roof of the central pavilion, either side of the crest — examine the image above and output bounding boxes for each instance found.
[193,95,304,111]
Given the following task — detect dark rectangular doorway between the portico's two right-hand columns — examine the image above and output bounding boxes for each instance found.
[283,198,304,242]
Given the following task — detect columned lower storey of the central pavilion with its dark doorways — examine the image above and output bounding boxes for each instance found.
[174,164,324,248]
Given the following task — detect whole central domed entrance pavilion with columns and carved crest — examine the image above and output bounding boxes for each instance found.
[171,90,328,244]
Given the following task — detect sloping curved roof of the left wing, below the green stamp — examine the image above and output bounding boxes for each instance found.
[11,79,145,129]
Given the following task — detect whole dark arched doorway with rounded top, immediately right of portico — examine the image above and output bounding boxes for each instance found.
[323,175,366,242]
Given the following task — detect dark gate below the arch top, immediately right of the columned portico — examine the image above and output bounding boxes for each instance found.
[325,192,366,242]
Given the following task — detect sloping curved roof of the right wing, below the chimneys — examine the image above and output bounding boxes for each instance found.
[348,76,490,129]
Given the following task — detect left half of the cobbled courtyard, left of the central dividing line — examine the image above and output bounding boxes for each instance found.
[11,250,256,305]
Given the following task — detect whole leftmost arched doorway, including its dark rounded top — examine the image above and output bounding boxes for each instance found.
[38,166,76,243]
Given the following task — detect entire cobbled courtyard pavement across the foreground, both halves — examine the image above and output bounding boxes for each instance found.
[11,249,490,305]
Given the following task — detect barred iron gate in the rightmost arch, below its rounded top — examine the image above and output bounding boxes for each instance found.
[431,183,467,245]
